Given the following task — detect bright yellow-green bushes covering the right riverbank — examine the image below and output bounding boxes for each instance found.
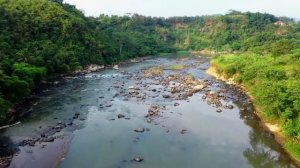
[212,50,300,158]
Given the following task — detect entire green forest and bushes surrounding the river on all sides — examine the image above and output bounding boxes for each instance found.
[0,0,300,158]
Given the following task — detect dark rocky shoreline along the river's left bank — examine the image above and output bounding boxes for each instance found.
[0,56,157,168]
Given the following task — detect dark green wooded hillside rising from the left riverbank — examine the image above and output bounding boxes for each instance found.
[0,0,175,124]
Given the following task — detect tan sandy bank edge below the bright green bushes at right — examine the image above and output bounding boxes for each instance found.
[207,56,300,166]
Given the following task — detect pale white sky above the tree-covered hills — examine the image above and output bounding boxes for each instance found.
[64,0,300,18]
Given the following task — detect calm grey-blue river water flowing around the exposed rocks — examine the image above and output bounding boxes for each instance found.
[1,57,297,168]
